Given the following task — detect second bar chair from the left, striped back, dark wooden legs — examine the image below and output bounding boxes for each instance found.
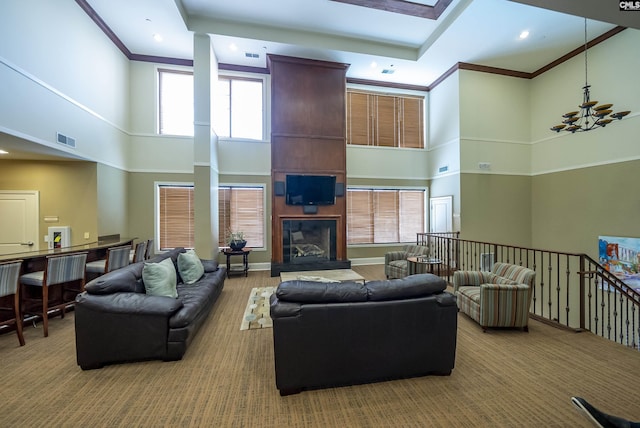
[20,252,87,337]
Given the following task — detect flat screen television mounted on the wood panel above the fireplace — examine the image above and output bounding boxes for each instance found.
[285,174,336,205]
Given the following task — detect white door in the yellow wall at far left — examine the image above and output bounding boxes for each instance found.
[0,190,40,254]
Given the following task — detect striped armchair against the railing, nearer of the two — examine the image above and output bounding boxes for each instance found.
[453,263,536,331]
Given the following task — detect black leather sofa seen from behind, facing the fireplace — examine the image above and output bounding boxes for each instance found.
[271,274,458,395]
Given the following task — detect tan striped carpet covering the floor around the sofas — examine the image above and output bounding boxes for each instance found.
[0,265,640,428]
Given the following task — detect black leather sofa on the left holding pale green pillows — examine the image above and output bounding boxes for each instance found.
[75,248,226,370]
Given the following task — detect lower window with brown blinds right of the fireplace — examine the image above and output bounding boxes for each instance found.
[347,188,426,245]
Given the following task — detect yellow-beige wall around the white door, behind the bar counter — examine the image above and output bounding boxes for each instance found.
[0,161,98,248]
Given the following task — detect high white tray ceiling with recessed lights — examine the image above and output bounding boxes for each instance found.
[0,0,640,160]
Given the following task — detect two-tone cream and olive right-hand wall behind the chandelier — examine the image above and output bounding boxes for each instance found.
[531,29,640,259]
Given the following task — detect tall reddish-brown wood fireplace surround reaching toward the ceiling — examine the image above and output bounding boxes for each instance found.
[268,55,351,276]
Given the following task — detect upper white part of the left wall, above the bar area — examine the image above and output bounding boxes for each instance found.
[0,0,129,167]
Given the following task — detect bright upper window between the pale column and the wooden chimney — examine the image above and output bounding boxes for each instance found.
[213,77,264,140]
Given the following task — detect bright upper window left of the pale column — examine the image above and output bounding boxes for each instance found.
[158,69,193,136]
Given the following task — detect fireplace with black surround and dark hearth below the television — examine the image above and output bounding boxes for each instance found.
[271,218,351,276]
